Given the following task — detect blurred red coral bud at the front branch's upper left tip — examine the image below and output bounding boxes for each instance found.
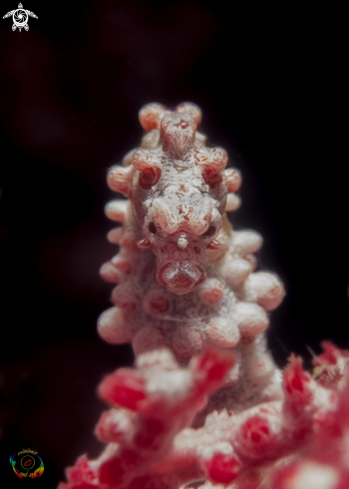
[98,369,146,411]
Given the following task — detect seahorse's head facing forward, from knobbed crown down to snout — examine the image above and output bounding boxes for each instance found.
[132,104,227,295]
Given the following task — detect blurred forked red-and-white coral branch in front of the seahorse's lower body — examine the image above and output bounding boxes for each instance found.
[60,350,235,489]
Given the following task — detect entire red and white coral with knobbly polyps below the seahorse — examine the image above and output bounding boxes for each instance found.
[60,349,349,489]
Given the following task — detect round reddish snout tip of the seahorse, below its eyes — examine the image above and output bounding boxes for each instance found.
[156,261,206,295]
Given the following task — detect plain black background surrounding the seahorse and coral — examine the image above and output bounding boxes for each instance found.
[0,0,349,488]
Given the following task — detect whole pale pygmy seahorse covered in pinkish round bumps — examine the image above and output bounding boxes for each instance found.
[98,103,284,416]
